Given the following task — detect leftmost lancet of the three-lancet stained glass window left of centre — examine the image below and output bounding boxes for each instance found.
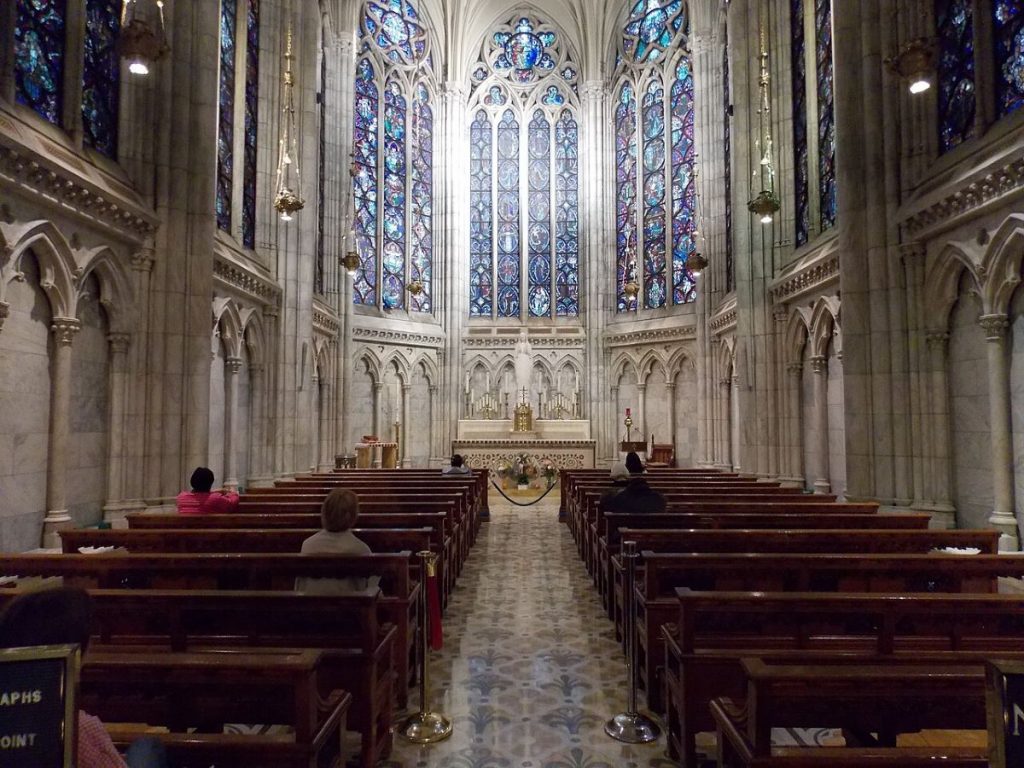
[352,58,380,305]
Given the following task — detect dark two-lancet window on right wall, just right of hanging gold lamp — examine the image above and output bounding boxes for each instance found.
[790,0,837,247]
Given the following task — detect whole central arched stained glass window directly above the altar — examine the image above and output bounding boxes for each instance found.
[468,15,580,321]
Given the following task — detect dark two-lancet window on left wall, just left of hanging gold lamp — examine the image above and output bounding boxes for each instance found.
[216,0,259,248]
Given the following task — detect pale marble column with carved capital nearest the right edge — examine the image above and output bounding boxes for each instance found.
[978,314,1019,551]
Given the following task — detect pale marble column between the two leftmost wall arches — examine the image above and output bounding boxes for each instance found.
[43,317,82,547]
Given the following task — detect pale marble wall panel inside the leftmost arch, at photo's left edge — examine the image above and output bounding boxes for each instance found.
[0,257,50,552]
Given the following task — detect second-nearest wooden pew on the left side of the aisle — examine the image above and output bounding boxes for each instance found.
[0,590,395,766]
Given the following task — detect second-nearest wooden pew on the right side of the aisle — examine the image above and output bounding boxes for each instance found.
[663,589,1024,768]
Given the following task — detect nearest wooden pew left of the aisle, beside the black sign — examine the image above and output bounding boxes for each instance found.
[79,649,352,768]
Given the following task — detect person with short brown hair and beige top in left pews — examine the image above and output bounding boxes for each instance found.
[295,488,380,595]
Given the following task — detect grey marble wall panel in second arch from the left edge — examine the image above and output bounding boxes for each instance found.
[67,275,110,525]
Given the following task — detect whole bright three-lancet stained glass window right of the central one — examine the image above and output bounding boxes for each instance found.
[613,0,696,312]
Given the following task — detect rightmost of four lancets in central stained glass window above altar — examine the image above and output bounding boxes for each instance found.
[555,110,580,317]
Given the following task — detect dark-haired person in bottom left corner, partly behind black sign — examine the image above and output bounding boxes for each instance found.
[0,587,168,768]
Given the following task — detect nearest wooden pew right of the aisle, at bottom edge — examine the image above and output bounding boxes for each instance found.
[711,658,988,768]
